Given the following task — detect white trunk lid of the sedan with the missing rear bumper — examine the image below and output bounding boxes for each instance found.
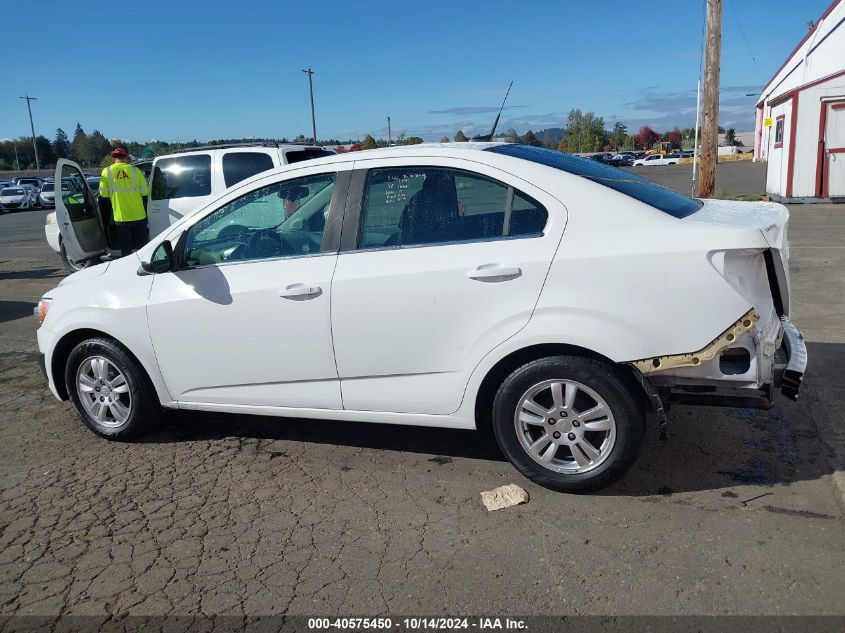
[683,199,790,316]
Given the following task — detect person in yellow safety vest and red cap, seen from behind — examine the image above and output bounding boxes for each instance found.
[99,147,150,256]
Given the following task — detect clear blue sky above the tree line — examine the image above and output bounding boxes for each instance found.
[0,0,830,141]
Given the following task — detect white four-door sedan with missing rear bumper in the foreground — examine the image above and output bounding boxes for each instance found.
[37,143,807,492]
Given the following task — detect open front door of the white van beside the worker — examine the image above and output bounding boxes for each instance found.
[55,158,108,262]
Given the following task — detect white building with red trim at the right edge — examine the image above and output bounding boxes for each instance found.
[754,0,845,201]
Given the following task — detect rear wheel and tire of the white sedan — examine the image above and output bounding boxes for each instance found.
[493,356,645,493]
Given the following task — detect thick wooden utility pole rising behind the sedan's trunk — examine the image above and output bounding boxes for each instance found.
[698,0,722,198]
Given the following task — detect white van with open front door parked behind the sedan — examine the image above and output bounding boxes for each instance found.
[44,143,335,270]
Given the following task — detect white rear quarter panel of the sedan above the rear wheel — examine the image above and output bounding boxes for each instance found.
[524,183,768,362]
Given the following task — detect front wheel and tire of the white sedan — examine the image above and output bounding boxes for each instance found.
[65,338,161,440]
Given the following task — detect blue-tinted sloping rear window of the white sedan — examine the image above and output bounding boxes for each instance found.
[486,145,703,218]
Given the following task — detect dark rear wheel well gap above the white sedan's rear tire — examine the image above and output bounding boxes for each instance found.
[475,343,648,436]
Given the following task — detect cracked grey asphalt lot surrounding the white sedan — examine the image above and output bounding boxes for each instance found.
[0,163,845,615]
